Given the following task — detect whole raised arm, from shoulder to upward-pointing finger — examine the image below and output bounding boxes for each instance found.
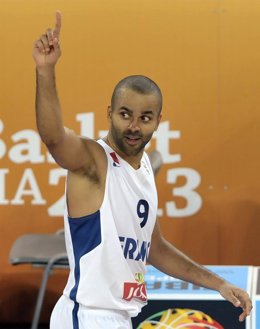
[33,11,104,171]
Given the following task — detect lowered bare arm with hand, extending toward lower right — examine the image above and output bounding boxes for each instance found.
[149,222,252,321]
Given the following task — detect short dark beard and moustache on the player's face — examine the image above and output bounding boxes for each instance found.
[111,122,153,156]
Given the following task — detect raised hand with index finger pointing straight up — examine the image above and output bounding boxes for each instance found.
[33,11,61,69]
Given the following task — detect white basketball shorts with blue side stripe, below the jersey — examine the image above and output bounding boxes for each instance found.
[50,296,132,329]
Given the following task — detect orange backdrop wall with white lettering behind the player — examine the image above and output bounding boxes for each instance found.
[0,0,260,322]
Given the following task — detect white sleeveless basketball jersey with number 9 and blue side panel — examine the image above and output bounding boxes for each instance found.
[64,140,158,322]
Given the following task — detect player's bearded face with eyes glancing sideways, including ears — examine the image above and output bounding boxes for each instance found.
[108,89,161,156]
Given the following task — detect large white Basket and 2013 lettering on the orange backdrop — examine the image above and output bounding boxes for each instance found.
[0,112,202,218]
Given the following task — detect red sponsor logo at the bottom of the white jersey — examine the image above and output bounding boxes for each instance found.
[123,273,147,302]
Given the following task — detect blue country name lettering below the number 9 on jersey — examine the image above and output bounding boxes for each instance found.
[119,236,150,262]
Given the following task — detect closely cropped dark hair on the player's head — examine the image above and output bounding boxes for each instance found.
[111,75,162,112]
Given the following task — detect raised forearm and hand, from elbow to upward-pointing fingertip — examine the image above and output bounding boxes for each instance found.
[33,12,65,145]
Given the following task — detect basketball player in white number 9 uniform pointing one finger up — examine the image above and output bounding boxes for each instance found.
[33,12,252,329]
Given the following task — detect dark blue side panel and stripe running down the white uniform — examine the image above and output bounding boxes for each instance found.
[68,210,101,329]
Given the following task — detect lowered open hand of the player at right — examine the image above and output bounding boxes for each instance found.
[219,282,253,321]
